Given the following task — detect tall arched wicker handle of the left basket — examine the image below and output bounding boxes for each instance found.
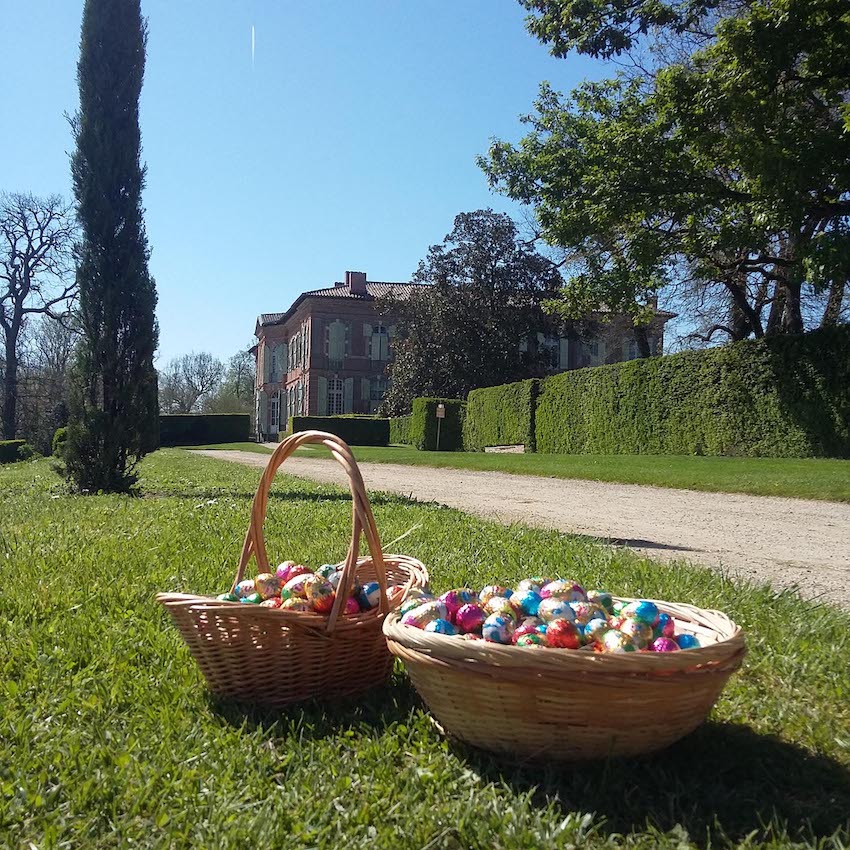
[233,431,389,632]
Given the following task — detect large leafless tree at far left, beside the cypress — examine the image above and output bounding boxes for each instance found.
[0,193,76,439]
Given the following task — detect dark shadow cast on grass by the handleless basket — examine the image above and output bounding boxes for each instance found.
[452,723,850,847]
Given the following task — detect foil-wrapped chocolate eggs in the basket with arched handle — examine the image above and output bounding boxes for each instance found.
[216,561,381,614]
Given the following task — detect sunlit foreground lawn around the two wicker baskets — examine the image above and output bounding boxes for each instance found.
[0,450,850,850]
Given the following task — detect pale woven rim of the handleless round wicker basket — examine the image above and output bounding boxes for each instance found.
[383,597,746,675]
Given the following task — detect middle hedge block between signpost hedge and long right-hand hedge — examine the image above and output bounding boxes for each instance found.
[463,378,540,452]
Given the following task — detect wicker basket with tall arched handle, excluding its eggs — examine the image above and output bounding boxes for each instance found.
[157,431,428,705]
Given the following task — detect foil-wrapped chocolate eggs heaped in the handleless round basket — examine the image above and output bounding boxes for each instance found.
[399,576,699,652]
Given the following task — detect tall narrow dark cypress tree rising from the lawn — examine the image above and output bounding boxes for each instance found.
[64,0,159,492]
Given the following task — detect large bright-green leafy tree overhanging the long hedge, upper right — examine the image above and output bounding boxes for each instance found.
[482,0,850,338]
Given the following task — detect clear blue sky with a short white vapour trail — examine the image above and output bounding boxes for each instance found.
[0,0,604,365]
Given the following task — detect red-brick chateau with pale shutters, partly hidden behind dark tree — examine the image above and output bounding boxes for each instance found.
[253,272,672,440]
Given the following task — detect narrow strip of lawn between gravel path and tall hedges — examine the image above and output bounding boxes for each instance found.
[286,446,850,502]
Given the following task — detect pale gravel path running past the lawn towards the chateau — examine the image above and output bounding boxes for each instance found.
[194,451,850,606]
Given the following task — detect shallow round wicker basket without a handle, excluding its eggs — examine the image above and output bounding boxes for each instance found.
[384,600,746,761]
